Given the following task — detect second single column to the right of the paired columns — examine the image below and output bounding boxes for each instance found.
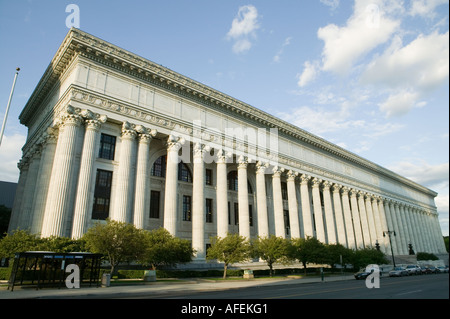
[192,143,206,260]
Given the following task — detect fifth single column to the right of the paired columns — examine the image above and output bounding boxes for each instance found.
[256,162,269,237]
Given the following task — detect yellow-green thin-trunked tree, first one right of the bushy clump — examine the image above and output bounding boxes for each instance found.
[206,234,250,279]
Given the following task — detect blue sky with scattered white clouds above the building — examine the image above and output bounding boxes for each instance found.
[0,0,449,235]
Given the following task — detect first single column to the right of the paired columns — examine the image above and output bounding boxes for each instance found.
[164,135,184,236]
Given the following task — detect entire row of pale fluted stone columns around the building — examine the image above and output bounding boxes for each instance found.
[10,110,445,259]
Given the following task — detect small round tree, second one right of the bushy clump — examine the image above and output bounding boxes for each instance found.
[252,235,290,277]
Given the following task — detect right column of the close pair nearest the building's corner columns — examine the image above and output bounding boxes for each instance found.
[133,126,156,229]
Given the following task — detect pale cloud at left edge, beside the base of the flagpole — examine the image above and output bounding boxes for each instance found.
[0,134,26,182]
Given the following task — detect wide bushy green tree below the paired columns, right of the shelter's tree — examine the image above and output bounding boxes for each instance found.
[138,228,194,270]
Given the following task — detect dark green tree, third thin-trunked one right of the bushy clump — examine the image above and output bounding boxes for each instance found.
[290,237,326,275]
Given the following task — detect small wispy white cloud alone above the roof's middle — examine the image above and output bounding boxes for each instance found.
[227,5,259,53]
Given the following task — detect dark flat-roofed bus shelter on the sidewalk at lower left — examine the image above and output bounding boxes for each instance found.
[8,251,102,291]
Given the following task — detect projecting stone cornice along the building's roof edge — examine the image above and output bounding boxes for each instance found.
[19,28,437,200]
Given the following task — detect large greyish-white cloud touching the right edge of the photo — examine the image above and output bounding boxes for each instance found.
[361,31,449,117]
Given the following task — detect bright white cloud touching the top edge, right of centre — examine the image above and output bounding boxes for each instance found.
[317,0,400,74]
